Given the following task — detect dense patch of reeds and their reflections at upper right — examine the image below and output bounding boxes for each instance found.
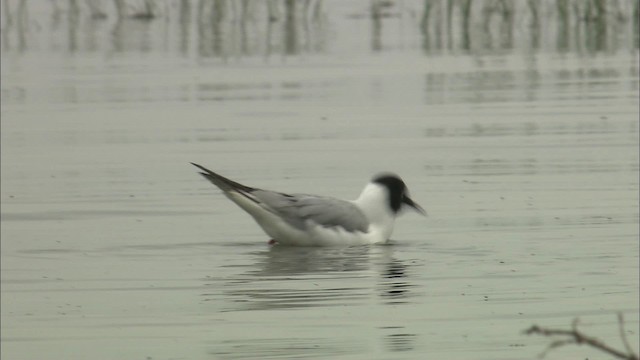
[418,0,638,52]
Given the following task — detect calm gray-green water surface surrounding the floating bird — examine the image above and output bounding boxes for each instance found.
[0,1,639,359]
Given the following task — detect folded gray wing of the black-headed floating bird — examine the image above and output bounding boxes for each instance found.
[252,189,369,232]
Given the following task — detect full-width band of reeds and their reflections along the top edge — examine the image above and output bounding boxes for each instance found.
[1,0,640,56]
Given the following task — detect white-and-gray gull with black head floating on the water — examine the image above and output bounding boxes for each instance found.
[191,163,426,246]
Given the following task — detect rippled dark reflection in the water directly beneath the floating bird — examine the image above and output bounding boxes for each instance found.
[203,246,418,311]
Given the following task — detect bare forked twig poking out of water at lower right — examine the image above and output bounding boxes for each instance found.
[524,313,639,360]
